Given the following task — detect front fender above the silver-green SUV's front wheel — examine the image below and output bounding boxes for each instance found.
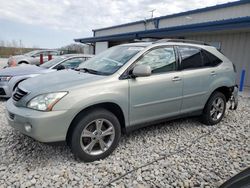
[53,80,129,125]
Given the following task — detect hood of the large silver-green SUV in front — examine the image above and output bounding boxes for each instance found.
[18,69,106,97]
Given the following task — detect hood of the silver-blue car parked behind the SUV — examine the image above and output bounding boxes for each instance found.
[0,65,52,76]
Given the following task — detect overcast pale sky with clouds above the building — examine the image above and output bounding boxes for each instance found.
[0,0,238,48]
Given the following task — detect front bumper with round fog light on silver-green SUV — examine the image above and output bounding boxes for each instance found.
[6,99,73,142]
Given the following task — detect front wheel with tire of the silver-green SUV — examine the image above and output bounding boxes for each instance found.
[69,109,121,162]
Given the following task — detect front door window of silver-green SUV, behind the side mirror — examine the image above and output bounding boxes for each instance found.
[136,47,176,74]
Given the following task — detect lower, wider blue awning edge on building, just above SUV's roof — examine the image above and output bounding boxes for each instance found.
[75,17,250,43]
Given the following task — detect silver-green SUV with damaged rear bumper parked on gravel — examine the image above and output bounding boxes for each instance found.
[6,40,237,161]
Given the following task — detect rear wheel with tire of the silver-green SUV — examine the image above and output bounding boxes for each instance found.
[201,91,226,125]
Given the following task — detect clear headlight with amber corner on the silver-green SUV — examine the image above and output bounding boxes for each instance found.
[27,92,68,111]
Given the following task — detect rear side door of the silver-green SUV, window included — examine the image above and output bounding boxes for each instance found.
[178,46,210,113]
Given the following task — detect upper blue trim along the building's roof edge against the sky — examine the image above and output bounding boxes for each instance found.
[93,0,250,32]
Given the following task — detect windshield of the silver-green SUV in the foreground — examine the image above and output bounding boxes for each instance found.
[78,46,144,75]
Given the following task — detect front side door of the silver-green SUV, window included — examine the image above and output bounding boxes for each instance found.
[129,46,183,125]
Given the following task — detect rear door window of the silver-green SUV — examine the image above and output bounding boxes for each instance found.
[178,46,202,69]
